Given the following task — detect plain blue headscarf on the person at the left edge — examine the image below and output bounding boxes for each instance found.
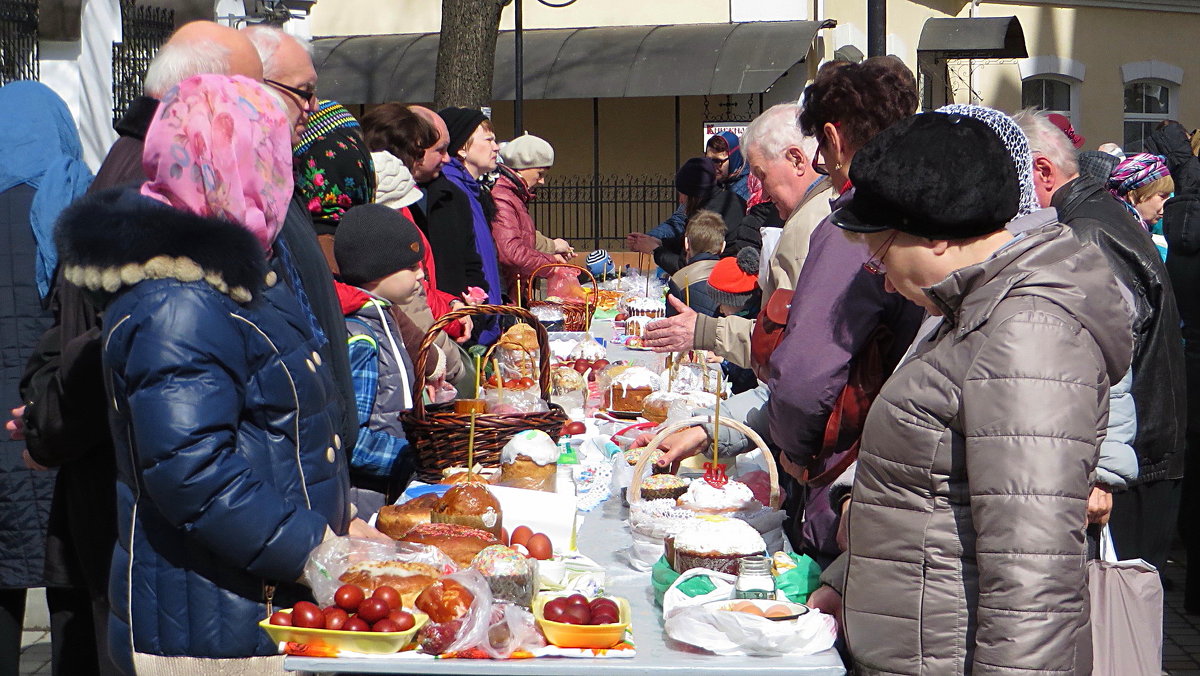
[0,80,92,298]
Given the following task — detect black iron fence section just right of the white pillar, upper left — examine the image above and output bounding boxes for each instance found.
[113,0,175,124]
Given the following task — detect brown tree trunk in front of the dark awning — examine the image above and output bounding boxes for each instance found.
[433,0,510,110]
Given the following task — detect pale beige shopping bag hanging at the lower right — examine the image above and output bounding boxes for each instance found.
[1087,526,1163,676]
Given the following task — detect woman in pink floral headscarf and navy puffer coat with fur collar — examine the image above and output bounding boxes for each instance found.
[56,76,369,674]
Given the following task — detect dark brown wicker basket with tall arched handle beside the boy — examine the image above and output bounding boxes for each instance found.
[401,305,568,483]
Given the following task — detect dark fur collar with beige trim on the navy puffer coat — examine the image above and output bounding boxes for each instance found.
[55,190,275,303]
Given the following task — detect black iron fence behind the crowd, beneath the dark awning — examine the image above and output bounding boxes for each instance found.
[529,175,676,250]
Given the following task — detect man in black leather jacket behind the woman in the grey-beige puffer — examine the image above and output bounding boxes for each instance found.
[1018,108,1187,569]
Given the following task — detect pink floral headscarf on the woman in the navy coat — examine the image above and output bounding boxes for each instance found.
[142,74,293,251]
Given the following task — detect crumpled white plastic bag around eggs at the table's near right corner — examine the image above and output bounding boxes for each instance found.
[664,602,838,657]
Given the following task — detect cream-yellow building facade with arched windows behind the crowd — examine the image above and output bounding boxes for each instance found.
[311,0,1200,169]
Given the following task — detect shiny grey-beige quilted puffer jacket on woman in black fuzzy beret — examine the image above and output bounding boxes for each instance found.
[845,225,1133,676]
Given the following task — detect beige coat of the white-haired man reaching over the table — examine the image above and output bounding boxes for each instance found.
[695,177,832,369]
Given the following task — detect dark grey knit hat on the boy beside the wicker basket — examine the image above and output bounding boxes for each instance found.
[334,204,425,286]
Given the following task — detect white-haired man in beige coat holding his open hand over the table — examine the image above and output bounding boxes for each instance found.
[646,103,829,367]
